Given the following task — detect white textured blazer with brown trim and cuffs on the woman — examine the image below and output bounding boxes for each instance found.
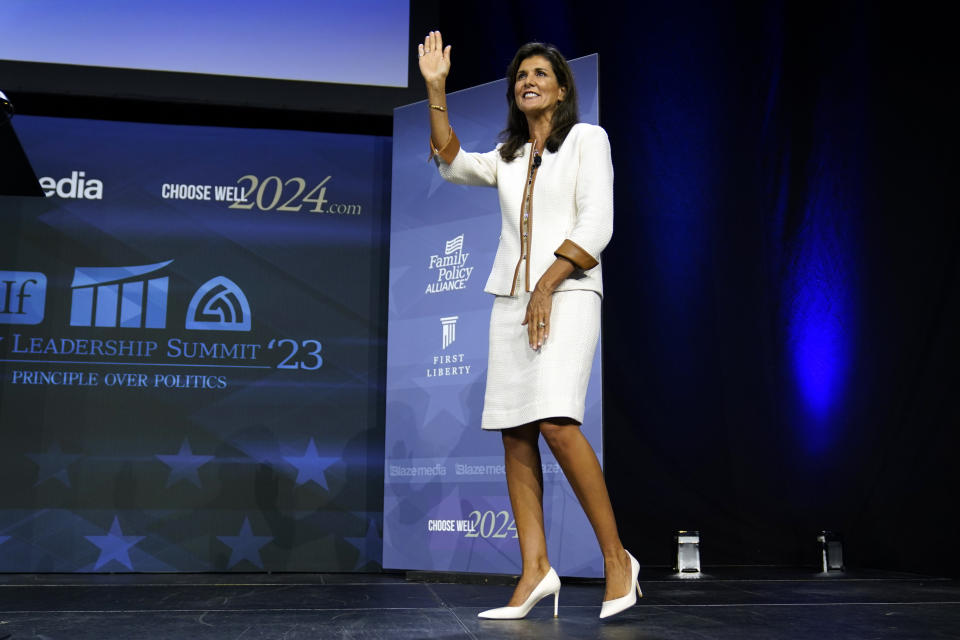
[435,122,613,296]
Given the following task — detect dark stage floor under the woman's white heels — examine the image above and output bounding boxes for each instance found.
[0,567,960,640]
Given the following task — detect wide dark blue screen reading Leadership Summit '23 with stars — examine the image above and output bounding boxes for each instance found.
[0,116,390,572]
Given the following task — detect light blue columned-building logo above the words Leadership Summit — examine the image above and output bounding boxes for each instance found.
[70,260,173,329]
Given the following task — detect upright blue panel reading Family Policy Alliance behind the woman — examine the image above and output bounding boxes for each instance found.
[383,55,603,577]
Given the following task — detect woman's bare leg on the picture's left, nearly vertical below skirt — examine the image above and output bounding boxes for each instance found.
[501,423,550,607]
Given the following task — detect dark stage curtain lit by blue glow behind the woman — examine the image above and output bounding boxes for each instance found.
[424,2,960,575]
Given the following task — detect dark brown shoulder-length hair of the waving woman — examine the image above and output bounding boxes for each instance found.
[500,42,580,162]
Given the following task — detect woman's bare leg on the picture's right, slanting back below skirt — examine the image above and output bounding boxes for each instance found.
[544,418,633,600]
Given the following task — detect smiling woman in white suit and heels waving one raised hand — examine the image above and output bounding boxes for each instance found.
[418,31,642,619]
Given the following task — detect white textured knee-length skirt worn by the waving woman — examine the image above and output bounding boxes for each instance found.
[480,290,600,429]
